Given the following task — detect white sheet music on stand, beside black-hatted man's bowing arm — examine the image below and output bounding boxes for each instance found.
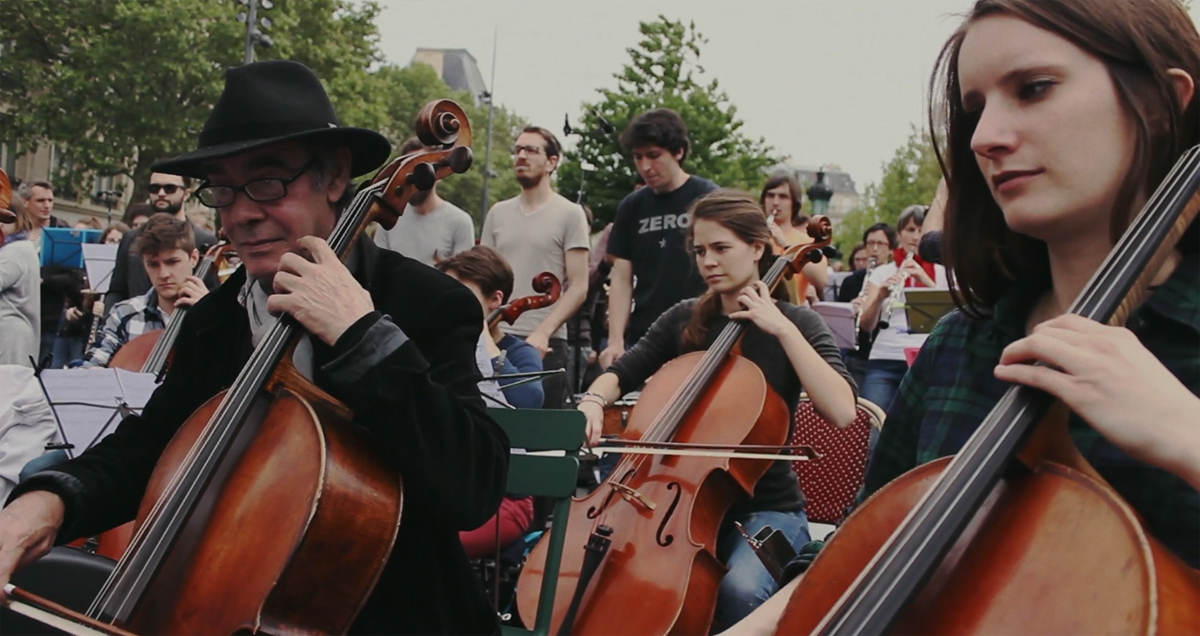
[41,368,157,455]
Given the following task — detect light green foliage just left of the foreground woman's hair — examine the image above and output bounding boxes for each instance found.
[834,126,942,254]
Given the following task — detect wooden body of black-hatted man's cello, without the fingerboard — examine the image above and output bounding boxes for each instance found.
[119,389,402,635]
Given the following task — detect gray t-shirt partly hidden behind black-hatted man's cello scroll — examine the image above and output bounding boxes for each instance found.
[376,200,475,266]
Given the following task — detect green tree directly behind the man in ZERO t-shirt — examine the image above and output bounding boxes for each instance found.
[558,16,780,228]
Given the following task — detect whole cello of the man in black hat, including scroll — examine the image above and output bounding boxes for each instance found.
[4,100,472,634]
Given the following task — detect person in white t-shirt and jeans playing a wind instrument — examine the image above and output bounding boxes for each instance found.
[859,205,948,449]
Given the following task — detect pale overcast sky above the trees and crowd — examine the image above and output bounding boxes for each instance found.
[369,0,1195,193]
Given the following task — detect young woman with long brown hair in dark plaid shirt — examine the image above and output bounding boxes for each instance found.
[727,0,1200,634]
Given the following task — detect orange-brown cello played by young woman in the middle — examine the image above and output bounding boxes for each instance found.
[517,216,832,635]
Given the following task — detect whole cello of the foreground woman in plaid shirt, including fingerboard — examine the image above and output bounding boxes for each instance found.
[775,146,1200,635]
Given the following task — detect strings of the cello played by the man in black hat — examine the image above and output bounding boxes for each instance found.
[89,185,383,613]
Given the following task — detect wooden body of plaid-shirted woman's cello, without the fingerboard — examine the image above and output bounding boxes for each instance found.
[775,421,1200,636]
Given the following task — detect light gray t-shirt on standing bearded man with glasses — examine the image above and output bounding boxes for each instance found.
[479,193,589,340]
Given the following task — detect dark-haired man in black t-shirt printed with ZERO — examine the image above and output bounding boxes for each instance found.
[600,108,718,368]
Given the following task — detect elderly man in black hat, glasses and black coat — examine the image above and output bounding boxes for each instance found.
[0,61,509,634]
